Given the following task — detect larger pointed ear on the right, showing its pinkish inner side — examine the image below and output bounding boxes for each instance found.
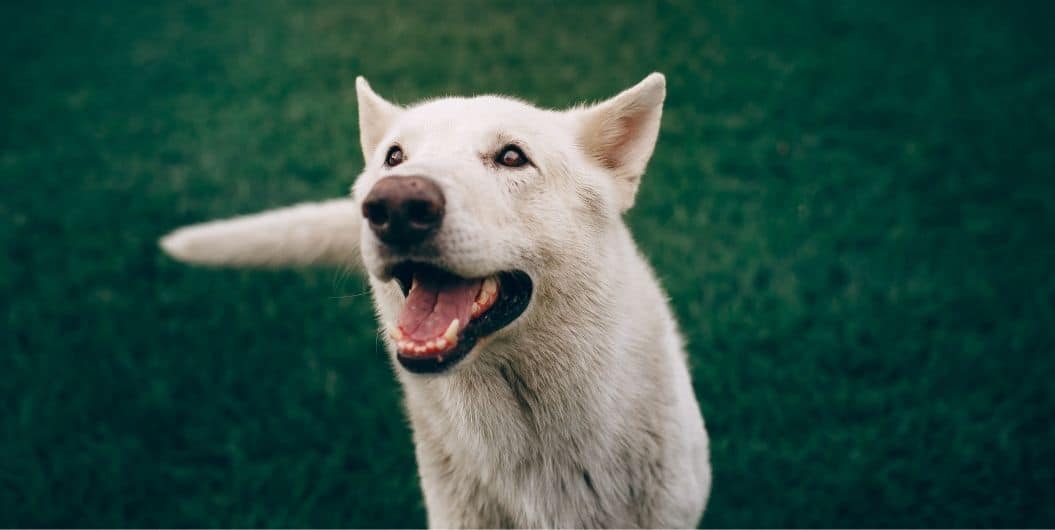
[578,73,667,211]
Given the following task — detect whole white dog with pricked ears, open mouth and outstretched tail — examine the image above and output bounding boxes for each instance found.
[161,74,711,528]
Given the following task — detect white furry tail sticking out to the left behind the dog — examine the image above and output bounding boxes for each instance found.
[160,198,362,269]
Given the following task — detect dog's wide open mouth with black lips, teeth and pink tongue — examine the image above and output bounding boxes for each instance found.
[391,262,532,374]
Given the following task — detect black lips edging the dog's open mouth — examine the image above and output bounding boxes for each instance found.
[394,265,534,374]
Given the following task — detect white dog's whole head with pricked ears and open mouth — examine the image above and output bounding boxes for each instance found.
[352,74,665,373]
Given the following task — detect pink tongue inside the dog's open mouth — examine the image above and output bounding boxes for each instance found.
[399,270,482,342]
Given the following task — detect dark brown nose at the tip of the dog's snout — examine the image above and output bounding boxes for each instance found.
[363,176,446,247]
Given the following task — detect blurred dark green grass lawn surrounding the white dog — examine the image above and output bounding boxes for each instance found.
[0,0,1055,527]
